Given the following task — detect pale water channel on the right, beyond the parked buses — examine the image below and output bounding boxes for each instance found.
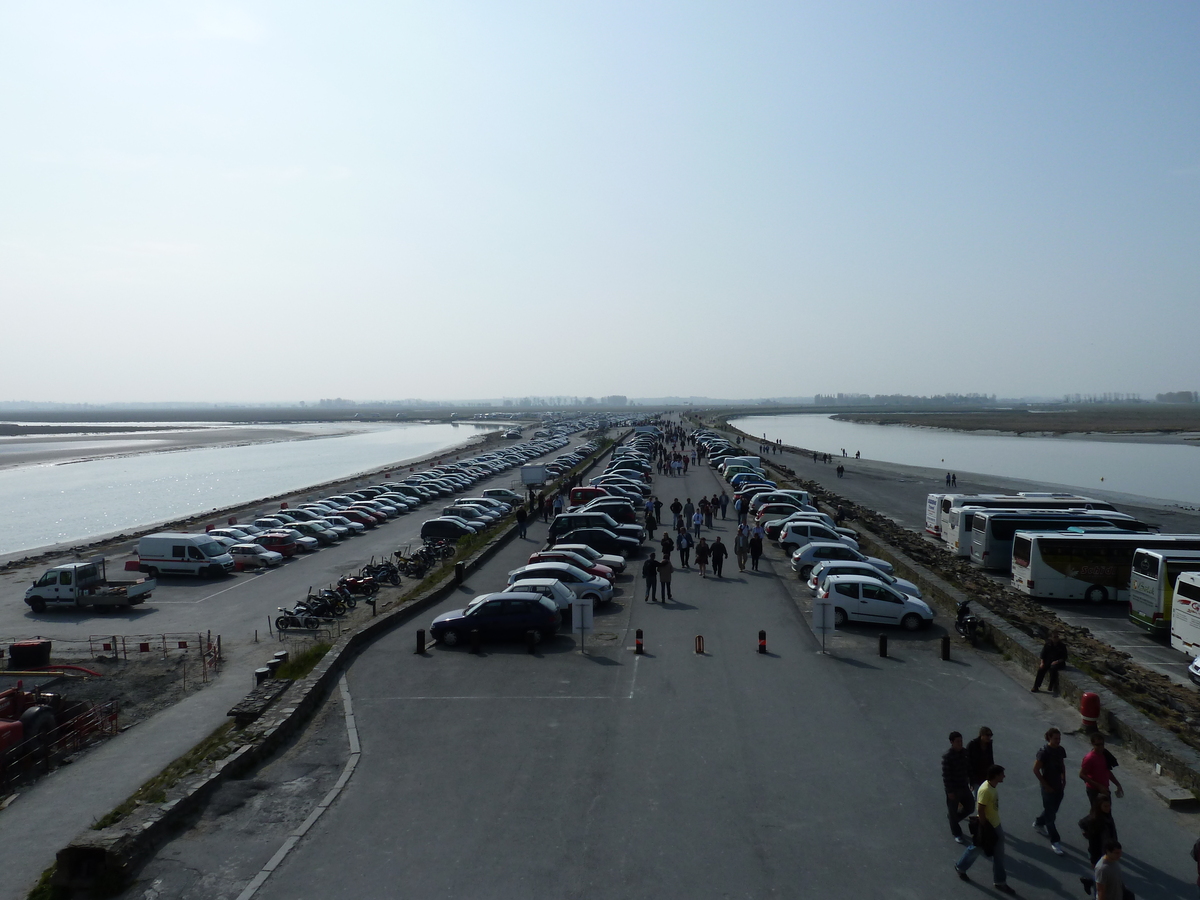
[731,413,1200,506]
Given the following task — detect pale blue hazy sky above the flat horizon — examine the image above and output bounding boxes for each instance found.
[0,0,1200,402]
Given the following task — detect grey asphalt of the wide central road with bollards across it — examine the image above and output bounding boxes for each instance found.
[126,446,1195,900]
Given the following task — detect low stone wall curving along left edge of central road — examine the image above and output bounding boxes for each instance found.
[46,432,630,892]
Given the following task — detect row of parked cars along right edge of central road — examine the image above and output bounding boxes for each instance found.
[695,431,934,630]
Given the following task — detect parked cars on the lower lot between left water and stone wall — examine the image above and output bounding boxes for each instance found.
[195,437,580,569]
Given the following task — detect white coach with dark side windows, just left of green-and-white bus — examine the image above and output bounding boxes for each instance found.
[1013,530,1200,602]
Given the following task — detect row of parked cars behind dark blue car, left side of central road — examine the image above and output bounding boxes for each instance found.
[430,437,653,647]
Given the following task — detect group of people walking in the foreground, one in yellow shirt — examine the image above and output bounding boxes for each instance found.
[942,729,1132,900]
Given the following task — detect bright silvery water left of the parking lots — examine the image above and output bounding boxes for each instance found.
[0,424,488,553]
